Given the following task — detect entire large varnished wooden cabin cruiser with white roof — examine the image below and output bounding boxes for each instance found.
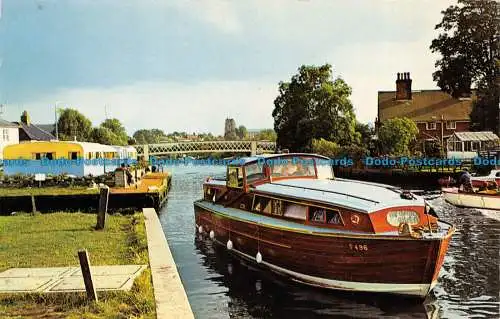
[194,153,455,298]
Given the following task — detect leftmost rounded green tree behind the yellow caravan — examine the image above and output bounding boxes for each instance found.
[57,108,92,141]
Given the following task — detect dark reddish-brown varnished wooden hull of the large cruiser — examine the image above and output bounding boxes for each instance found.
[195,201,451,298]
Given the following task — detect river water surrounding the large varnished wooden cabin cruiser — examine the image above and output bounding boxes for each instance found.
[160,166,500,319]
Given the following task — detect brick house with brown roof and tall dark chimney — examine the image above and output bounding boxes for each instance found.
[375,72,475,150]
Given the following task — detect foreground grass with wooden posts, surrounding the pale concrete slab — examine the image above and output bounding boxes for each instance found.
[0,213,155,318]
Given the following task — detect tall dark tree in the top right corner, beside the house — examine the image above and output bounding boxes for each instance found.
[430,0,500,132]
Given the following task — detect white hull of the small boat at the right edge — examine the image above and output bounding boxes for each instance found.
[442,187,500,210]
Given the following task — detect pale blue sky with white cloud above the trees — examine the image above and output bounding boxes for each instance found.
[0,0,455,134]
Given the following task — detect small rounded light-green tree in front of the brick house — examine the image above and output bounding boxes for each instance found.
[378,117,418,156]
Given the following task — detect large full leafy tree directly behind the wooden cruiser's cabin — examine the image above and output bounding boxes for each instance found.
[273,64,359,152]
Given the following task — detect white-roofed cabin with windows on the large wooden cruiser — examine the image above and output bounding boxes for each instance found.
[203,154,437,234]
